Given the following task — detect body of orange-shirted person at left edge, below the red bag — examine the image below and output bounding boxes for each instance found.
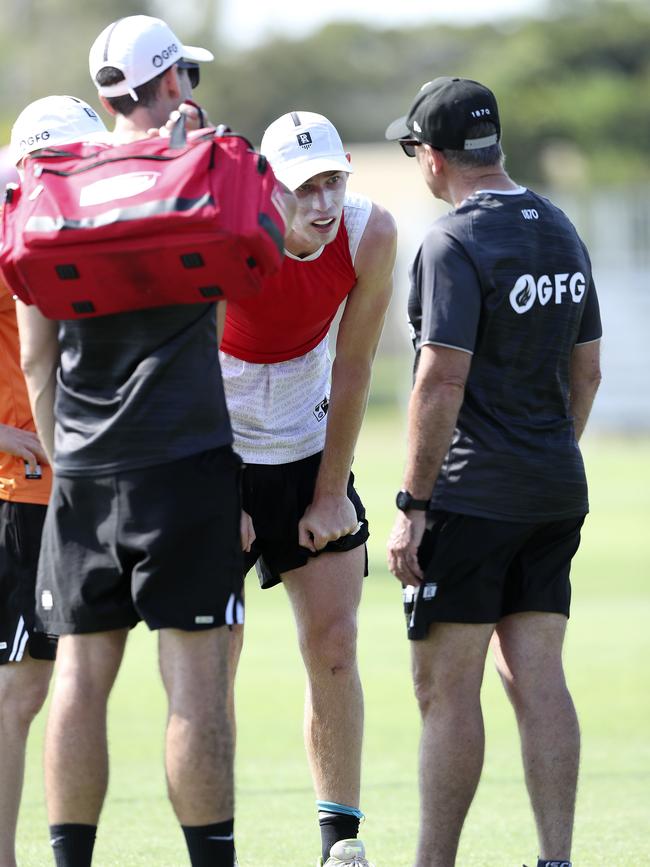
[0,282,56,867]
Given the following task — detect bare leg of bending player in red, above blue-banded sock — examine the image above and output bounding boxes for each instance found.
[283,547,365,808]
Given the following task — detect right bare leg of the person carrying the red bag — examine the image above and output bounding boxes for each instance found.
[159,626,234,826]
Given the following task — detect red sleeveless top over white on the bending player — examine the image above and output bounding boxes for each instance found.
[221,217,357,364]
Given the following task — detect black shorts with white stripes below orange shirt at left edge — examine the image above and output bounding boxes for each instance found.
[0,500,56,665]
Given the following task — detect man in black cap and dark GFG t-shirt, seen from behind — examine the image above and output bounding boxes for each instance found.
[386,78,601,867]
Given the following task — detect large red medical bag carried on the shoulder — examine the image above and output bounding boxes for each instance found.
[0,127,285,319]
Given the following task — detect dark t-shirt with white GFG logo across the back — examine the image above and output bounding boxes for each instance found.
[409,188,601,522]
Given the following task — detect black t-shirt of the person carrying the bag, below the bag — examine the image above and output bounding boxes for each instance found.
[54,304,232,476]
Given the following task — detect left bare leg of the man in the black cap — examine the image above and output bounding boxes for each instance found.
[412,623,494,867]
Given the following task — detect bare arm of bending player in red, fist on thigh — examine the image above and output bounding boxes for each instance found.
[299,205,397,550]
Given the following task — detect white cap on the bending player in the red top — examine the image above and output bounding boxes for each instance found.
[260,111,352,190]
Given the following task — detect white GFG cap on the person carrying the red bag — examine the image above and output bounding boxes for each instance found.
[88,15,214,102]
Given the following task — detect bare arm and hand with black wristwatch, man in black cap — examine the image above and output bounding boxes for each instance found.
[388,346,472,586]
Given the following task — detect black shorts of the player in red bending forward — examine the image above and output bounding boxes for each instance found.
[242,452,370,589]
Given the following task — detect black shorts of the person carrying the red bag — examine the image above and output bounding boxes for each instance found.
[37,446,243,634]
